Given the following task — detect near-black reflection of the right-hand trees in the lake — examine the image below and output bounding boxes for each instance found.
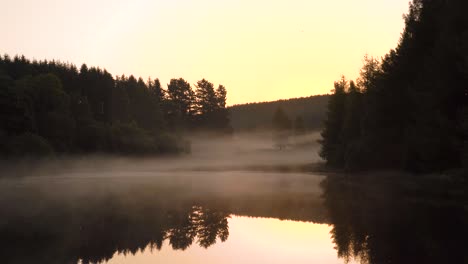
[322,175,468,264]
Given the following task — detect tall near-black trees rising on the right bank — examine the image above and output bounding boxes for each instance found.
[320,0,468,172]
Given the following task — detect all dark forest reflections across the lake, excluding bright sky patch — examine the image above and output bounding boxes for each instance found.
[0,173,468,264]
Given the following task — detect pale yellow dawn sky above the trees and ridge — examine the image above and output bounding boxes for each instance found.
[0,0,409,105]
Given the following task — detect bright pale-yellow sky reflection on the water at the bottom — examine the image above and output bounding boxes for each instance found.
[102,216,352,264]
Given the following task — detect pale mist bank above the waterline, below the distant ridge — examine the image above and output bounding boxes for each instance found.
[2,132,321,177]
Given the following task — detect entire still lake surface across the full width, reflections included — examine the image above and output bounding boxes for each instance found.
[0,163,468,264]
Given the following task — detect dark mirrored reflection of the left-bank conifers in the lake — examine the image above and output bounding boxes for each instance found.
[0,189,230,263]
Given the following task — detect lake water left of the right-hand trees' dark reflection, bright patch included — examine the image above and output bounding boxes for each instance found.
[0,168,344,263]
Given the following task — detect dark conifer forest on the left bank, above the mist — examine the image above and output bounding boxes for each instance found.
[0,55,231,156]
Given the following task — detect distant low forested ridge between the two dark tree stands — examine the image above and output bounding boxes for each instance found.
[228,95,329,131]
